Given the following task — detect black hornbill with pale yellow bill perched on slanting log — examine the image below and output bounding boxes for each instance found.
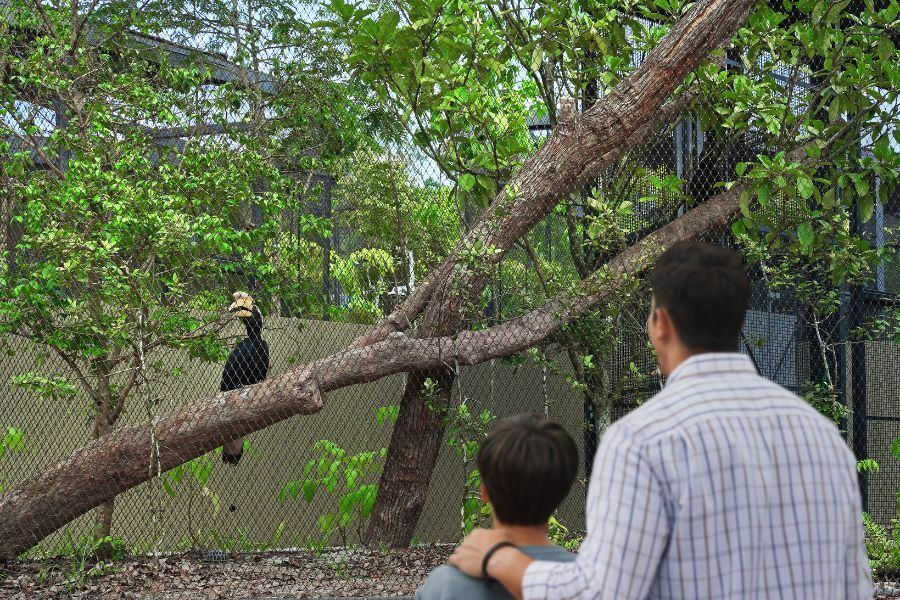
[219,292,269,465]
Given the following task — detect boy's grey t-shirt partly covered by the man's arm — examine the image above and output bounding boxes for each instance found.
[416,546,575,600]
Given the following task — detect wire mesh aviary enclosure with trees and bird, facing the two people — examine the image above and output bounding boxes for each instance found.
[0,0,900,596]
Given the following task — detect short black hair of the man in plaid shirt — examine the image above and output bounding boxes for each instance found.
[650,242,750,352]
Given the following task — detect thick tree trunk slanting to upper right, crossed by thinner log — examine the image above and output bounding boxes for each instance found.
[355,0,751,546]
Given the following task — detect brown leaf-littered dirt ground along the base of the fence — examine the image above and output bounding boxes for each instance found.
[0,545,900,600]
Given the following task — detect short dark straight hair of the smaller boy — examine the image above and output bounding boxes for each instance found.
[478,415,578,525]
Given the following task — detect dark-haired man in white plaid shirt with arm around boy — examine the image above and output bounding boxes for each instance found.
[450,242,872,600]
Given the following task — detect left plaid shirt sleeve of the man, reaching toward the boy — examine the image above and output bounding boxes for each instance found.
[522,424,670,600]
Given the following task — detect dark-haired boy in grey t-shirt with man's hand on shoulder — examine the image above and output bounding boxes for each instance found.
[416,415,578,600]
